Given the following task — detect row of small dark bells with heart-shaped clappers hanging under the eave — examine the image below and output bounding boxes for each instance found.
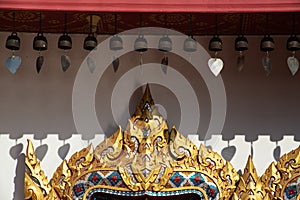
[5,13,300,76]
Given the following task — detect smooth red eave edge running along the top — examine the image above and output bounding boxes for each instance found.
[0,0,300,13]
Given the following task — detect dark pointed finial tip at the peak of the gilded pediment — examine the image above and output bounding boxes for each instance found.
[134,83,154,122]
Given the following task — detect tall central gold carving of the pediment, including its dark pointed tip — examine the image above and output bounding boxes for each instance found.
[119,85,172,191]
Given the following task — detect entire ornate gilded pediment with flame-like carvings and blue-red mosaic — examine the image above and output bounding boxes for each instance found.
[24,85,300,200]
